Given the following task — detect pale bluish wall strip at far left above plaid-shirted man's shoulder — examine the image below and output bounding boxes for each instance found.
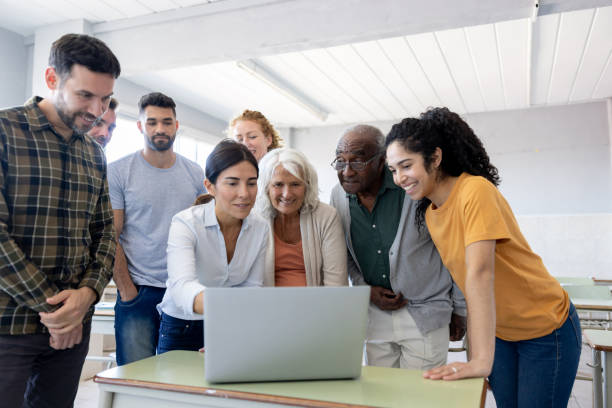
[0,28,28,108]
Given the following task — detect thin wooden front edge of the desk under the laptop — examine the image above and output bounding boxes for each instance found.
[94,375,372,408]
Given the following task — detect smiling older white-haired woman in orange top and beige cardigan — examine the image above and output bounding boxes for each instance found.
[255,148,348,286]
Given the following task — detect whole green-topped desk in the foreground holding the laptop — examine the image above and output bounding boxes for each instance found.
[94,351,486,408]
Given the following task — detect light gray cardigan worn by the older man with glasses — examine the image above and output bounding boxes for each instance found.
[331,184,466,334]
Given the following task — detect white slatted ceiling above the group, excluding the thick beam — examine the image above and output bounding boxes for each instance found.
[0,0,612,127]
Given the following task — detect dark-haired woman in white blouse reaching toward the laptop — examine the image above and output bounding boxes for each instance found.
[157,140,269,354]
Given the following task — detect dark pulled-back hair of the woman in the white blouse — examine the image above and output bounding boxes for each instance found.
[193,139,259,205]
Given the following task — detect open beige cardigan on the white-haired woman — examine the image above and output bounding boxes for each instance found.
[264,202,348,286]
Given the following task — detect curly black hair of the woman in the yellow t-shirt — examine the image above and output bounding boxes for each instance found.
[385,108,500,229]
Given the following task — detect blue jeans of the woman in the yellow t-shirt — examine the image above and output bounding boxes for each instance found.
[489,303,582,408]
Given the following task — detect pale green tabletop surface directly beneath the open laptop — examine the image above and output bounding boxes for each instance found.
[94,351,483,408]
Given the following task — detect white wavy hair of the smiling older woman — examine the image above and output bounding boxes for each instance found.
[255,148,319,218]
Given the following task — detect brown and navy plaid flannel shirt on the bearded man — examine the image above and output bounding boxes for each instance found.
[0,97,115,335]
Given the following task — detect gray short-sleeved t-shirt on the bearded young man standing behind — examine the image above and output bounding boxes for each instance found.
[108,151,206,287]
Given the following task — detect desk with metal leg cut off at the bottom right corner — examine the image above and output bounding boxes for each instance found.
[584,330,612,408]
